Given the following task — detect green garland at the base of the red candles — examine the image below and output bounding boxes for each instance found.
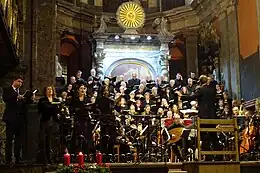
[56,164,110,173]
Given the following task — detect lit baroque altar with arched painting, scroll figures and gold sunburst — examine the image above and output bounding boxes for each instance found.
[93,2,173,80]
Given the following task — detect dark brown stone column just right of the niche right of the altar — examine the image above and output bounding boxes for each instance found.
[185,31,199,76]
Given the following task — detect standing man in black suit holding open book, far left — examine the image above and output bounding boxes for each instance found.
[3,76,32,164]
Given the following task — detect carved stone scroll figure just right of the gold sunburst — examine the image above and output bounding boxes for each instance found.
[153,17,174,37]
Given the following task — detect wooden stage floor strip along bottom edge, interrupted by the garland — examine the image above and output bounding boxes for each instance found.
[0,161,260,173]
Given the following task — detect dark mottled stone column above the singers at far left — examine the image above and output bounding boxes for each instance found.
[32,0,57,89]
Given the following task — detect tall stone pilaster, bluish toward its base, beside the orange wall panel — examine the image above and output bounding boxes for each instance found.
[219,5,241,99]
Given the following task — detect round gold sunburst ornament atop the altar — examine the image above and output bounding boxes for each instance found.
[116,2,145,29]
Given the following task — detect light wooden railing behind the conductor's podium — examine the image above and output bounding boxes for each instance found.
[197,118,239,161]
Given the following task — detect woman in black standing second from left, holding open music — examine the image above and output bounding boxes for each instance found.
[38,86,60,164]
